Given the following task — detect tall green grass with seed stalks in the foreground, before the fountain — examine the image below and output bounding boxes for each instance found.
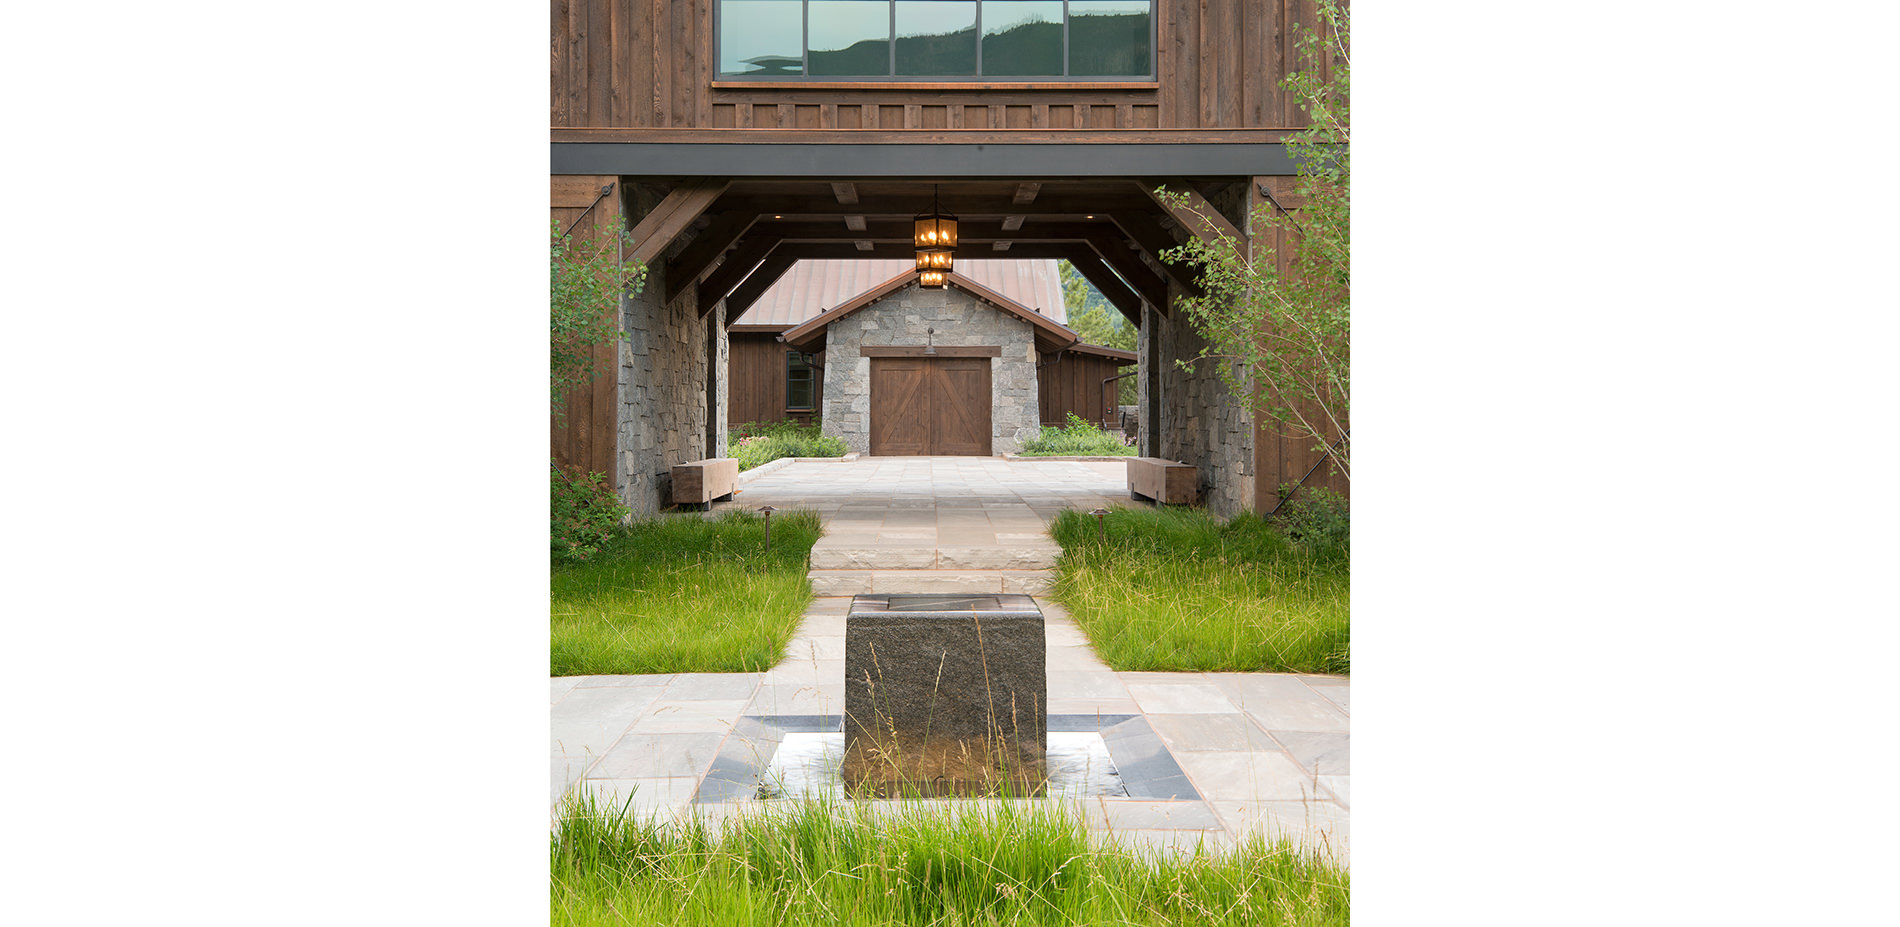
[551,798,1351,927]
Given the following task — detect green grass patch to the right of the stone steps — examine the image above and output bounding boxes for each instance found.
[1049,507,1353,674]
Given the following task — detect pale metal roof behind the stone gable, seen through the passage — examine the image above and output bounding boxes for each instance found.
[732,258,1068,329]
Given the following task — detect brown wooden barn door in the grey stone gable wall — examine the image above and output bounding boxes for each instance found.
[870,357,992,458]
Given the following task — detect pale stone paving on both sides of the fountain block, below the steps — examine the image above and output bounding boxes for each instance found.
[551,596,1351,861]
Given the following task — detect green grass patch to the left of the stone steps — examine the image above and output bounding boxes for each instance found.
[551,511,821,676]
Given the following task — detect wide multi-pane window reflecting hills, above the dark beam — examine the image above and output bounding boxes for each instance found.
[716,0,1155,80]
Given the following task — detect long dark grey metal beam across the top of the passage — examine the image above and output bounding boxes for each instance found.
[549,142,1294,180]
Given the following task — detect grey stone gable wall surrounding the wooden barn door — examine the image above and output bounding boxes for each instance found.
[823,283,1041,454]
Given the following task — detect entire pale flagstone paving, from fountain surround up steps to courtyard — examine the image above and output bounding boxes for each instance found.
[551,458,1351,861]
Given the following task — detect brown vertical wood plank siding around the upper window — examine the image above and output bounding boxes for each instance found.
[549,0,1317,131]
